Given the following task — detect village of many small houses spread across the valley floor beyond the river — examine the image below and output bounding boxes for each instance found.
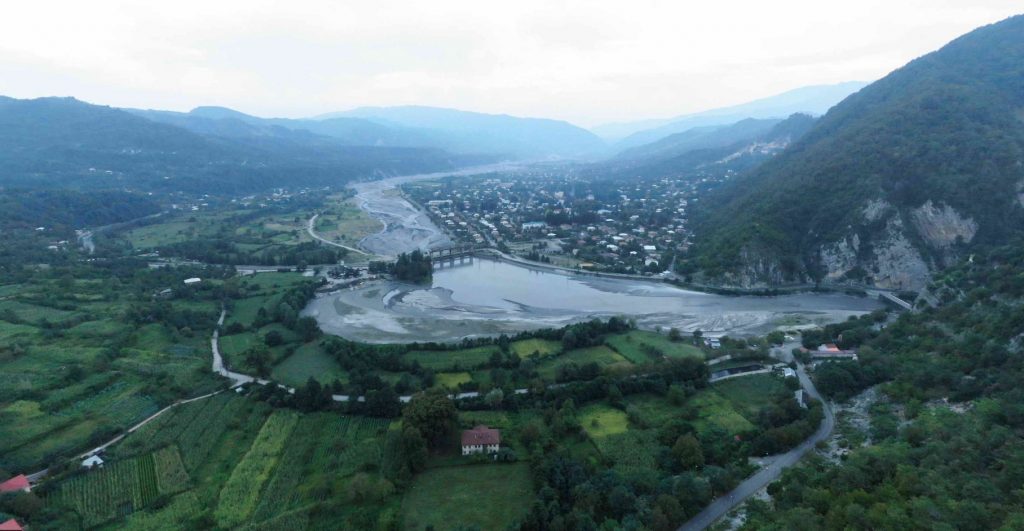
[402,170,728,275]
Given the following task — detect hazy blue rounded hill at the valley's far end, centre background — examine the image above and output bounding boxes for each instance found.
[317,105,605,159]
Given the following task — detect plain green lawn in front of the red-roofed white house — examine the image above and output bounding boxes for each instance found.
[402,462,534,531]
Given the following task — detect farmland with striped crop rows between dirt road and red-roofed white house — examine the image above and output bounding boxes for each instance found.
[40,392,389,529]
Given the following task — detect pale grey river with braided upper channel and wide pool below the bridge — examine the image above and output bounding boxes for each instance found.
[302,165,881,343]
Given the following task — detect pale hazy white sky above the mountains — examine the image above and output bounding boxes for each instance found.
[0,0,1024,126]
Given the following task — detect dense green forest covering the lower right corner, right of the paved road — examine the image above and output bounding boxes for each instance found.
[745,241,1024,529]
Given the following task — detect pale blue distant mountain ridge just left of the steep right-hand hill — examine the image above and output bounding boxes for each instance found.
[591,81,867,151]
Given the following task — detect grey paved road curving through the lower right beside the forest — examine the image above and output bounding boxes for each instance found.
[679,364,836,531]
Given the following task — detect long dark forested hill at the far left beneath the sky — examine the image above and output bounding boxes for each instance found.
[0,98,479,193]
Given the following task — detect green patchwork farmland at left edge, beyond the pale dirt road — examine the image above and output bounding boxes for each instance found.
[0,268,220,472]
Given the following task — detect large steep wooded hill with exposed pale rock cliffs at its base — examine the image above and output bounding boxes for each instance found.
[684,16,1024,289]
